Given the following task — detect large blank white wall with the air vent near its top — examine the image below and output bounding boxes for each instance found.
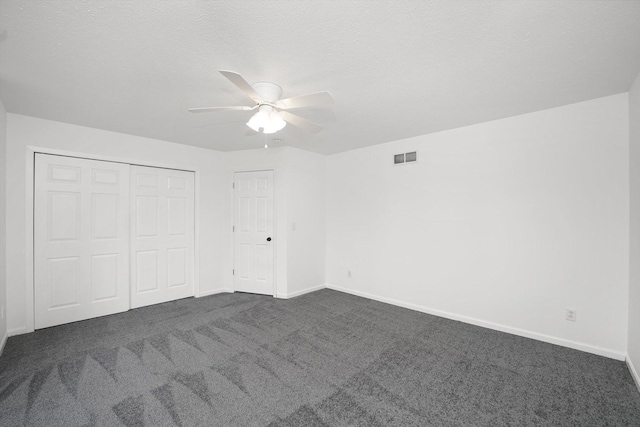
[327,93,629,359]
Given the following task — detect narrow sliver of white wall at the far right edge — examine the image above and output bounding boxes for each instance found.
[628,74,640,389]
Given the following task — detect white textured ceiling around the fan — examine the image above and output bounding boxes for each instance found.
[0,0,640,153]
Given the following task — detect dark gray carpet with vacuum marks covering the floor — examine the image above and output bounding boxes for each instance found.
[0,290,640,426]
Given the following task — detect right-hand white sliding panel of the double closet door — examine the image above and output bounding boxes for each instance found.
[131,166,195,308]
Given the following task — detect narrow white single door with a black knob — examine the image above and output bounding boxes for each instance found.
[233,171,274,295]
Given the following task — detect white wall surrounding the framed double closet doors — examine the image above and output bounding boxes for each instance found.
[6,114,226,334]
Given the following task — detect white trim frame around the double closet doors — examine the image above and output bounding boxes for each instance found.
[25,145,201,333]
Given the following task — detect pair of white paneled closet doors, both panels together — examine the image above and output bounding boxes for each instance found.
[34,154,194,329]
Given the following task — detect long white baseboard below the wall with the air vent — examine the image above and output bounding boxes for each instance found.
[326,283,626,361]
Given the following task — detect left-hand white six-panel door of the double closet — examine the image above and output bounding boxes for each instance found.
[34,154,129,329]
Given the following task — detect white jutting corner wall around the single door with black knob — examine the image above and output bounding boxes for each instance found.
[224,147,326,298]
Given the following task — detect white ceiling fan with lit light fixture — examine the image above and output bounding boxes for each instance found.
[189,71,335,133]
